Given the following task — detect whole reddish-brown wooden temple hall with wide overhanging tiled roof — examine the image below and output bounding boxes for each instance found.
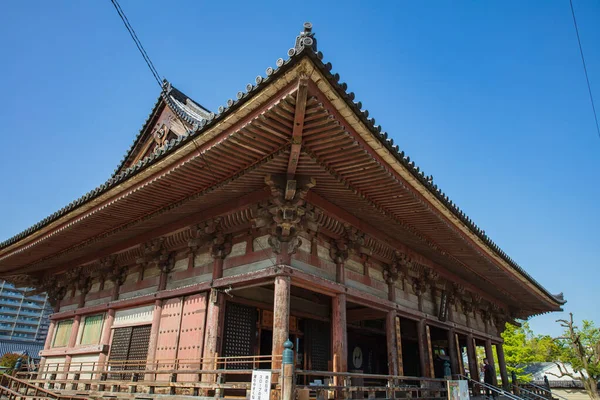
[0,23,564,399]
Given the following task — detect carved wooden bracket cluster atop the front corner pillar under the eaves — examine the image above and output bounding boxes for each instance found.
[262,175,318,254]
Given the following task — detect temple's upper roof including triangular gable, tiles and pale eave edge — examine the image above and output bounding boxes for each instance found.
[0,23,565,309]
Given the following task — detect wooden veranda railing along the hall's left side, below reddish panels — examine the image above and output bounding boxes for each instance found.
[17,355,281,397]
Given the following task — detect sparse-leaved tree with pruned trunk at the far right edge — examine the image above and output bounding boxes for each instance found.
[550,313,600,400]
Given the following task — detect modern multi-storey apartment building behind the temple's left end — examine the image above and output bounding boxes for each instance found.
[0,280,52,358]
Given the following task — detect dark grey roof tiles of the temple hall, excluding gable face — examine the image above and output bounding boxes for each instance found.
[0,23,566,304]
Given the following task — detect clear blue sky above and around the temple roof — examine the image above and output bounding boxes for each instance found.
[0,0,600,334]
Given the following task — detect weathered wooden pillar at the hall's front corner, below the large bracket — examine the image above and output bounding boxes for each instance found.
[271,275,291,369]
